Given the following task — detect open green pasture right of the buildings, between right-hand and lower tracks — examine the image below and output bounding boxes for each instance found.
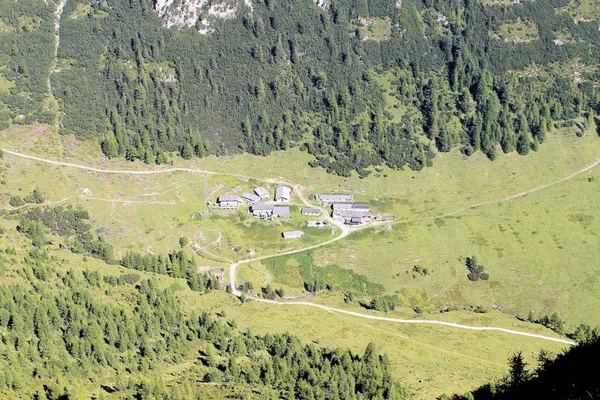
[313,162,600,325]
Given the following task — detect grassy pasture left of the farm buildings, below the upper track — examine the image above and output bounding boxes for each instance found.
[0,152,335,266]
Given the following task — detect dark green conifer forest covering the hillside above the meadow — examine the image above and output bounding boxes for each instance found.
[0,0,600,176]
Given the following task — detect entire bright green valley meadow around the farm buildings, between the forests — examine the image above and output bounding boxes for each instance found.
[0,127,600,398]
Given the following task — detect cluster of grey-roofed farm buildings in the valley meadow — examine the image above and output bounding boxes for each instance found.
[217,186,374,239]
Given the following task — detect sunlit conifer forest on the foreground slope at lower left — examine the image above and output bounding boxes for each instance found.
[0,223,409,399]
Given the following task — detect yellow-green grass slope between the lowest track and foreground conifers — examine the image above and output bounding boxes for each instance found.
[196,292,562,399]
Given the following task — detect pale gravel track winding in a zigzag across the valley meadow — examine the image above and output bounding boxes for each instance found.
[2,149,600,345]
